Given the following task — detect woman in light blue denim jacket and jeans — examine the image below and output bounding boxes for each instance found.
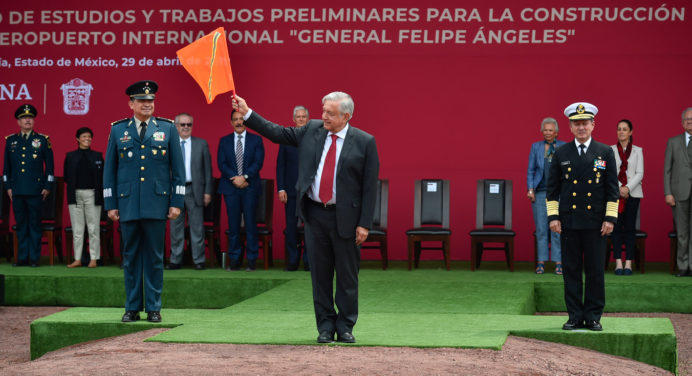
[526,117,565,275]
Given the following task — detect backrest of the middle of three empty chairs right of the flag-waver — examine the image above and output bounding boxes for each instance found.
[413,179,449,228]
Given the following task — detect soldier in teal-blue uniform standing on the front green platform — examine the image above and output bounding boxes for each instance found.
[103,81,185,322]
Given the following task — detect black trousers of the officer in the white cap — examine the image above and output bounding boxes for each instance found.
[560,229,606,321]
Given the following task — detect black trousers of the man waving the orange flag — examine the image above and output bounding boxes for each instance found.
[304,198,360,333]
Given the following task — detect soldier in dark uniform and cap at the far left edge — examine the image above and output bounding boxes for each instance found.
[2,104,55,267]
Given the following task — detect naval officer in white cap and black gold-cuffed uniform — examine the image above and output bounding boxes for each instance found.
[546,102,620,331]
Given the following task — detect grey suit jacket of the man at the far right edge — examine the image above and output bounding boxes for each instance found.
[663,133,692,201]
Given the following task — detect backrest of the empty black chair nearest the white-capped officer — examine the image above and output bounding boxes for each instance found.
[476,179,512,229]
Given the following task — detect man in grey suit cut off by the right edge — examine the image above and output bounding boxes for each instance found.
[663,107,692,277]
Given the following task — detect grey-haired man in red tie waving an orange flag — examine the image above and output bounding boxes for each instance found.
[233,91,380,343]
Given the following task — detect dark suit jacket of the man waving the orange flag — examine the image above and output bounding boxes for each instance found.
[245,111,380,238]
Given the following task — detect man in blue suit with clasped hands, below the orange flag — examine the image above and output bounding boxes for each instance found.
[218,110,264,272]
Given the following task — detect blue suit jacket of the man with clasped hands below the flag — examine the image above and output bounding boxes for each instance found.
[218,132,264,195]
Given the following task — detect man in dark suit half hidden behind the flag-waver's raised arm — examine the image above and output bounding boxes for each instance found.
[276,106,310,272]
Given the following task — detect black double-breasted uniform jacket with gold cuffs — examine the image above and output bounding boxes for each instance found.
[546,139,620,230]
